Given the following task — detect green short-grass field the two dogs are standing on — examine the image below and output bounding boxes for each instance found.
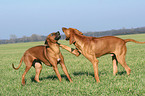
[0,34,145,96]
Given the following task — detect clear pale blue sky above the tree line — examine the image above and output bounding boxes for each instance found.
[0,0,145,40]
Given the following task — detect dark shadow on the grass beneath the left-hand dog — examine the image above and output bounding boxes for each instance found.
[31,75,69,83]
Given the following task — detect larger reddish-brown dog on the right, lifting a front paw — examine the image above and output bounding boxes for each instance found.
[60,28,145,82]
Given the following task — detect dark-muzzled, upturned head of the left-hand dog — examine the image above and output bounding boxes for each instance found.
[45,31,61,45]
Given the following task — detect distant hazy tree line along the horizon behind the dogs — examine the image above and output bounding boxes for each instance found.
[0,27,145,44]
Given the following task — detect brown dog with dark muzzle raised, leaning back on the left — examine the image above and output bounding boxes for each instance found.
[12,32,72,85]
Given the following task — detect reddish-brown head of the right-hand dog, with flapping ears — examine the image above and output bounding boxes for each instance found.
[62,27,83,44]
